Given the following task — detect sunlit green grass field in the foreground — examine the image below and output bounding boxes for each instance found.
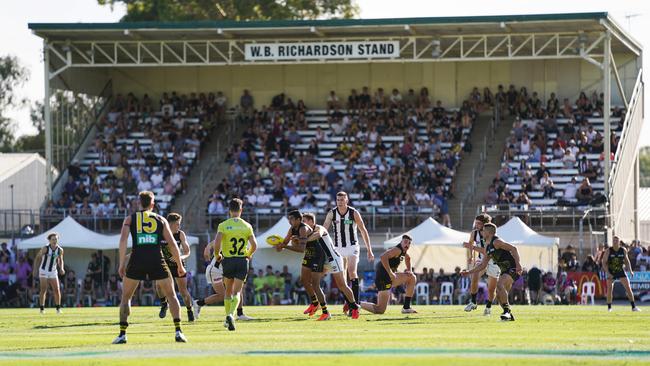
[0,306,650,366]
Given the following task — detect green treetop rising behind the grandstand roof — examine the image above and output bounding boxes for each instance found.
[97,0,359,22]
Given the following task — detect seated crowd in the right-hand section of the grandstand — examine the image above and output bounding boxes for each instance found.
[485,85,625,208]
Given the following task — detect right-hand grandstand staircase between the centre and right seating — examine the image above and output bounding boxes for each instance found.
[449,112,512,230]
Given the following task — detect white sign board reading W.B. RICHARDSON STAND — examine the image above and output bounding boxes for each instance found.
[246,41,399,61]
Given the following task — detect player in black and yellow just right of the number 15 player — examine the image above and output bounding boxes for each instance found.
[156,212,194,322]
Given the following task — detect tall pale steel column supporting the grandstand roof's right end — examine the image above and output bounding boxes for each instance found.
[602,30,614,229]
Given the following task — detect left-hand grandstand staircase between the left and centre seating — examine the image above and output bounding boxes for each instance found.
[170,118,245,235]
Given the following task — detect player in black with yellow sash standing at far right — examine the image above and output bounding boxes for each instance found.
[603,236,641,311]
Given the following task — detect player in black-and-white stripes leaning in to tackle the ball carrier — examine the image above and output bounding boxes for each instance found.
[302,213,359,319]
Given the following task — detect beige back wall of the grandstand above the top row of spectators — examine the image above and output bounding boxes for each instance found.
[109,56,635,108]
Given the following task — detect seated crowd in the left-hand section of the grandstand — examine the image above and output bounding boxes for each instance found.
[44,92,214,223]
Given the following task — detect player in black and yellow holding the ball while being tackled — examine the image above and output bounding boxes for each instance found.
[276,210,331,321]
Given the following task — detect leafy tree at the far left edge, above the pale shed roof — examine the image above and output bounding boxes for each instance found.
[0,55,29,152]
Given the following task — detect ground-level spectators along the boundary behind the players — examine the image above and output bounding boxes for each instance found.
[0,241,650,307]
